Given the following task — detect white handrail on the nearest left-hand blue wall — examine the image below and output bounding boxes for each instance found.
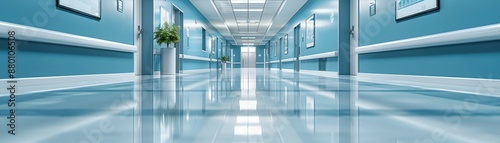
[0,21,137,52]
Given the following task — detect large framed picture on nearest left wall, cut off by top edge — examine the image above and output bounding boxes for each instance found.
[56,0,102,20]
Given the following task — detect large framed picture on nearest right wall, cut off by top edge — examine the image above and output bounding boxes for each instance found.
[396,0,439,21]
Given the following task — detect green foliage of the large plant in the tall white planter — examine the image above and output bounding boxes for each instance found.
[154,22,181,47]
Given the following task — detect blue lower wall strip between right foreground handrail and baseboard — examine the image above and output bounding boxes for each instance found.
[359,41,500,79]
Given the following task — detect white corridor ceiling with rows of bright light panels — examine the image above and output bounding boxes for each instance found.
[190,0,307,45]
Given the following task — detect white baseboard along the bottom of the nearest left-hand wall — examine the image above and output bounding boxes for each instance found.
[0,73,135,96]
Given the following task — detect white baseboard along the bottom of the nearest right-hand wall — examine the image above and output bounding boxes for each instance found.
[357,73,500,97]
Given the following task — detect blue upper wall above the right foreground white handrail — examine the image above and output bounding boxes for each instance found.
[359,0,500,46]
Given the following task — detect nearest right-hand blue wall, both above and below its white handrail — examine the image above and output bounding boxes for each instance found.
[359,0,500,79]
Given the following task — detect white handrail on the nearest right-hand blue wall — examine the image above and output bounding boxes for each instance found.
[356,24,500,54]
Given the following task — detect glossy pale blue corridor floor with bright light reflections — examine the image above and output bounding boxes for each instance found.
[0,69,500,143]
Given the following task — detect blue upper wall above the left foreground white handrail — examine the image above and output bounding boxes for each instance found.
[0,0,134,45]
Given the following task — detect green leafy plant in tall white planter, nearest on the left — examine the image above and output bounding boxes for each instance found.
[154,22,181,75]
